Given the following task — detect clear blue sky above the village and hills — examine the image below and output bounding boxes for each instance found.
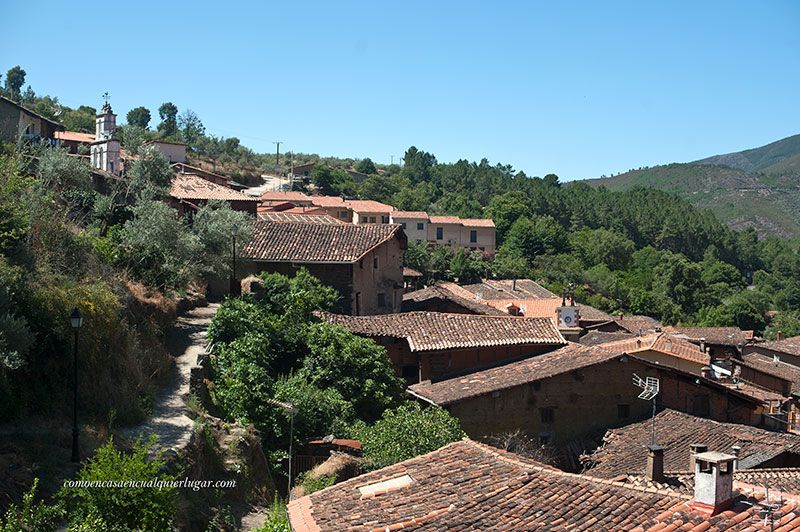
[0,0,800,180]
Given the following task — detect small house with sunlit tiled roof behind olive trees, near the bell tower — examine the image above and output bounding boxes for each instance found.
[168,173,259,216]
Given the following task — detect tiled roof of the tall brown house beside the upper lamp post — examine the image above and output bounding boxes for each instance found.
[241,216,400,263]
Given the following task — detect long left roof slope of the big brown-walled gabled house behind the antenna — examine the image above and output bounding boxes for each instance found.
[409,342,623,405]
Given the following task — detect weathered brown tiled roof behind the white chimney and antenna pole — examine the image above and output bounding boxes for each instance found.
[583,410,800,478]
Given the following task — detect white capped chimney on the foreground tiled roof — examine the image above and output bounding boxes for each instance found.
[692,451,736,515]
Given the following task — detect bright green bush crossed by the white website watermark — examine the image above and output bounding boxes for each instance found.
[61,437,176,531]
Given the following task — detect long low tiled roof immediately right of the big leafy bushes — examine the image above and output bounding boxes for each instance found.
[319,312,565,352]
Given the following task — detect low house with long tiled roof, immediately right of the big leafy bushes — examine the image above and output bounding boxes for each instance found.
[322,312,566,382]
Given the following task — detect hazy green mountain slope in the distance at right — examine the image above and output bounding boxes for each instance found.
[588,135,800,237]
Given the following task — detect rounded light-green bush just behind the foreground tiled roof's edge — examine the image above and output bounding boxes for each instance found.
[357,402,466,468]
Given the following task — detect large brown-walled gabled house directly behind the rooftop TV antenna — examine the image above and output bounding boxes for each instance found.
[408,343,786,444]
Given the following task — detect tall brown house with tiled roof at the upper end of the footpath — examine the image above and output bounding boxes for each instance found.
[239,217,400,316]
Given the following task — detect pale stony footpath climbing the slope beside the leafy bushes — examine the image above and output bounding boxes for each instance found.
[117,304,219,451]
